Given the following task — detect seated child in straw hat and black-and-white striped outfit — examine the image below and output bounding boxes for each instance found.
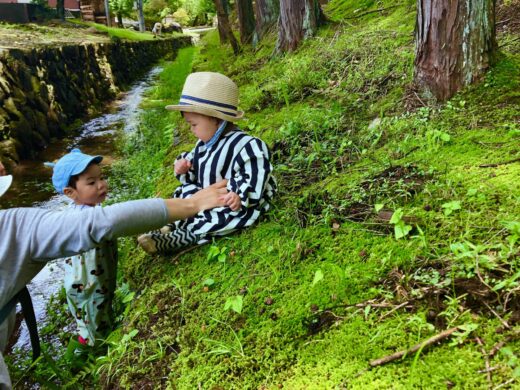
[138,72,276,254]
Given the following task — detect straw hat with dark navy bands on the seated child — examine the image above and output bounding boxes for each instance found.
[166,72,244,122]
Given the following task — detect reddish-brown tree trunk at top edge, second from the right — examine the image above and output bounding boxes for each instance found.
[276,0,323,52]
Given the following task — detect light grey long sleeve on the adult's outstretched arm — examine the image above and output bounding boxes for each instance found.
[28,199,168,260]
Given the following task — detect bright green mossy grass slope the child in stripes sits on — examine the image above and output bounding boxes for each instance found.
[5,0,520,389]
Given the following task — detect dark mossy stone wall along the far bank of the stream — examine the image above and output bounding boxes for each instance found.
[0,37,190,166]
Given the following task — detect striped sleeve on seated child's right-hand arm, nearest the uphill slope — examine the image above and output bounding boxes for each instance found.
[227,138,273,207]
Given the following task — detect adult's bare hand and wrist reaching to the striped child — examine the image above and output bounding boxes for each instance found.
[165,180,228,221]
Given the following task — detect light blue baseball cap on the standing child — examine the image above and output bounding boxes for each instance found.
[52,149,103,194]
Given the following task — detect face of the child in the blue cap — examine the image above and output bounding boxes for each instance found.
[63,164,108,206]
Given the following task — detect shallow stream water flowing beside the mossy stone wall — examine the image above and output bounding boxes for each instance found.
[0,67,162,349]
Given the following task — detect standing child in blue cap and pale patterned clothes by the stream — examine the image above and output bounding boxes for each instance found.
[52,149,117,346]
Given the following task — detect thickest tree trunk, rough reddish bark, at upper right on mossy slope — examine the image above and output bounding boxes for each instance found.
[414,0,497,101]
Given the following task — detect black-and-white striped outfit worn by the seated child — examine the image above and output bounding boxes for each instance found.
[151,128,276,252]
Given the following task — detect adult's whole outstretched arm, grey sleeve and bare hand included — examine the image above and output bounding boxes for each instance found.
[16,181,226,260]
